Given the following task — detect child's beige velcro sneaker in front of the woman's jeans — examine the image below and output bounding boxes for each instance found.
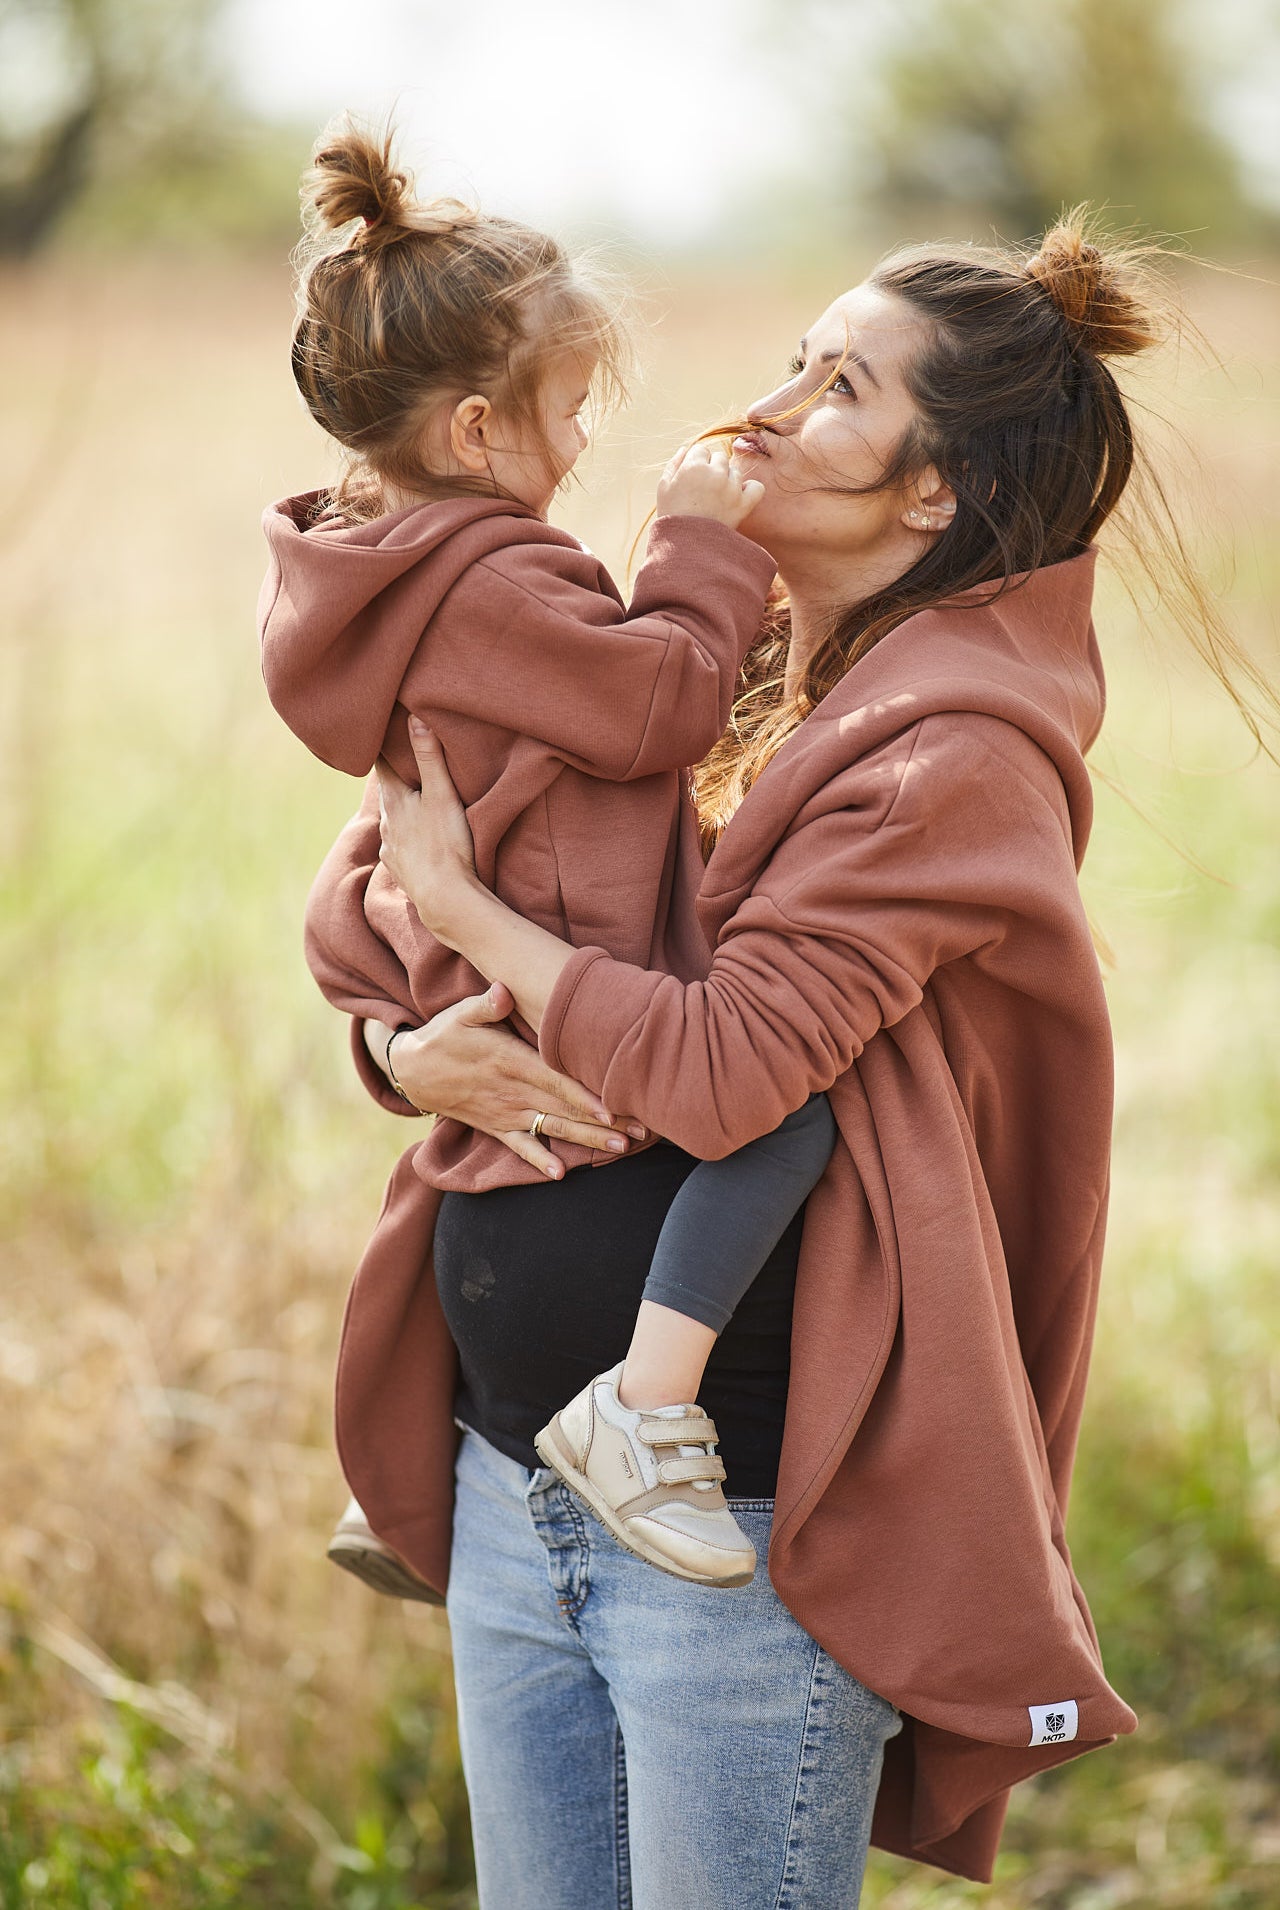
[533,1360,755,1585]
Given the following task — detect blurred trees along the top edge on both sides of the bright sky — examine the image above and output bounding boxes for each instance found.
[0,0,1280,256]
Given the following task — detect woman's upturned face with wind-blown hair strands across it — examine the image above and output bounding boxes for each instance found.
[734,285,949,602]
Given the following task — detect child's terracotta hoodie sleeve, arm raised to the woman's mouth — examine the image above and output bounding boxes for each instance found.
[399,518,774,781]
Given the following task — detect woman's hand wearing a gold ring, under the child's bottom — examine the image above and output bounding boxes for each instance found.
[365,982,646,1180]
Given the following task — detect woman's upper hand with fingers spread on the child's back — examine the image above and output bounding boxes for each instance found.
[378,716,481,947]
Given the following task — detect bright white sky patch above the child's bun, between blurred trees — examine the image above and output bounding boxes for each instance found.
[225,0,817,243]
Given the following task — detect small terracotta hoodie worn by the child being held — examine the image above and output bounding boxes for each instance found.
[258,493,774,1192]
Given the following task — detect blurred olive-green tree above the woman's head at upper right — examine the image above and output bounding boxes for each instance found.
[862,0,1251,237]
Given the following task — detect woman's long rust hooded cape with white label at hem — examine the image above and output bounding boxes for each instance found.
[309,554,1135,1879]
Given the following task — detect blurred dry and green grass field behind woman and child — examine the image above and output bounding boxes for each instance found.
[0,262,1280,1910]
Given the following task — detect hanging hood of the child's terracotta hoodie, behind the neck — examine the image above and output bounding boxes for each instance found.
[258,491,546,775]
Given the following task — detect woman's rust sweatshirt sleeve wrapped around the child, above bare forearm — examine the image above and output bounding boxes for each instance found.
[541,714,1087,1159]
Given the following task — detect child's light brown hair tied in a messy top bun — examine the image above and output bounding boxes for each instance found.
[292,120,629,518]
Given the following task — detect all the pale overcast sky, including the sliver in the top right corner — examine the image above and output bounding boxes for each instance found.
[224,0,1280,246]
